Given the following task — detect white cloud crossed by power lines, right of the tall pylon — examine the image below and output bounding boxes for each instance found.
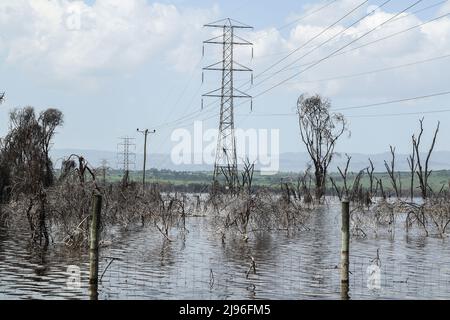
[251,0,450,101]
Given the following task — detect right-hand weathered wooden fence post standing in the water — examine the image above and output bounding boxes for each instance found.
[341,198,350,300]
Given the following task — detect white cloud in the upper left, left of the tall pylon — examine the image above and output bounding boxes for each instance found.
[0,0,217,79]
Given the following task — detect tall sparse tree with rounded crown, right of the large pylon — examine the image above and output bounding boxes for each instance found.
[297,94,347,201]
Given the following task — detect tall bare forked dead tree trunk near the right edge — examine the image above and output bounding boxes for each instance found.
[412,118,440,200]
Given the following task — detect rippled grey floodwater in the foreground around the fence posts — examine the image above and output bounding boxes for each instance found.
[0,207,450,299]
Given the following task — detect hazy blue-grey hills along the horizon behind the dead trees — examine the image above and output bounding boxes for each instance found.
[51,149,450,172]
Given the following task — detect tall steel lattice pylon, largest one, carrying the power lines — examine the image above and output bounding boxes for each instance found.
[202,18,253,189]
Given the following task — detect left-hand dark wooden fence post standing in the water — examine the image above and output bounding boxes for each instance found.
[89,194,102,300]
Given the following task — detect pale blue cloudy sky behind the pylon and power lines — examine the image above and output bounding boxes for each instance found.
[0,0,450,165]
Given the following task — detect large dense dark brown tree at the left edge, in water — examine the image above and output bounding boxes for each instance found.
[0,107,63,245]
